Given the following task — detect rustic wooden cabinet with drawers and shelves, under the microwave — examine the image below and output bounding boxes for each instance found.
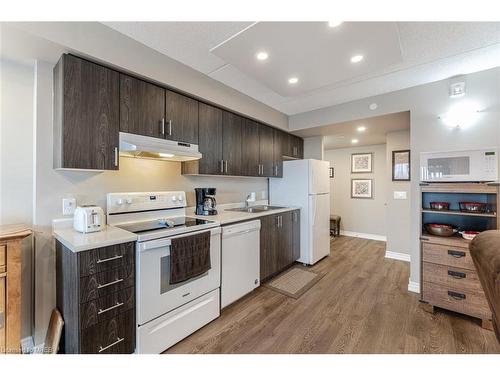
[420,183,499,328]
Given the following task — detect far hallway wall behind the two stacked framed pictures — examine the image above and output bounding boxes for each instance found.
[324,144,388,237]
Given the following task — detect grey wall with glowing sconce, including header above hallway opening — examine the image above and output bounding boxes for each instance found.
[289,68,500,290]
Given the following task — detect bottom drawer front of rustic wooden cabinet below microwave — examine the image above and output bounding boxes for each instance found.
[422,282,491,319]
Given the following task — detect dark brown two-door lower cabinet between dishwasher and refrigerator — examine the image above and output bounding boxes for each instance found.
[260,210,300,280]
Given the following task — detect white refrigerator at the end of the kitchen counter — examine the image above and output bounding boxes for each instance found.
[269,159,330,265]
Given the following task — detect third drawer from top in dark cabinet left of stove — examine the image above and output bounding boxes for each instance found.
[80,287,135,329]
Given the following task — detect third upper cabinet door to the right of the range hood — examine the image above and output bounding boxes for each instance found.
[241,119,260,176]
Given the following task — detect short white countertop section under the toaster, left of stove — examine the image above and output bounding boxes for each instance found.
[53,225,137,253]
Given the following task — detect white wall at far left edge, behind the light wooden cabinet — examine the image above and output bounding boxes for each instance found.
[0,60,33,337]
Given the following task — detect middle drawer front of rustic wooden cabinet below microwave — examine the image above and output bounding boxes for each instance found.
[422,262,483,292]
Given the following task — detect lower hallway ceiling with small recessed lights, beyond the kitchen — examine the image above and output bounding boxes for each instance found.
[294,111,410,150]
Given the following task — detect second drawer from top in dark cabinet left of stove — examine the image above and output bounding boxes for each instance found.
[80,264,135,303]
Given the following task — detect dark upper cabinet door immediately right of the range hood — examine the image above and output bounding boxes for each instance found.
[198,103,223,175]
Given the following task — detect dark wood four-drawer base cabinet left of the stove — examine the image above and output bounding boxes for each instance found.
[56,241,135,354]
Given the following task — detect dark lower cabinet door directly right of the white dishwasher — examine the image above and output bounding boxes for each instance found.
[260,215,278,283]
